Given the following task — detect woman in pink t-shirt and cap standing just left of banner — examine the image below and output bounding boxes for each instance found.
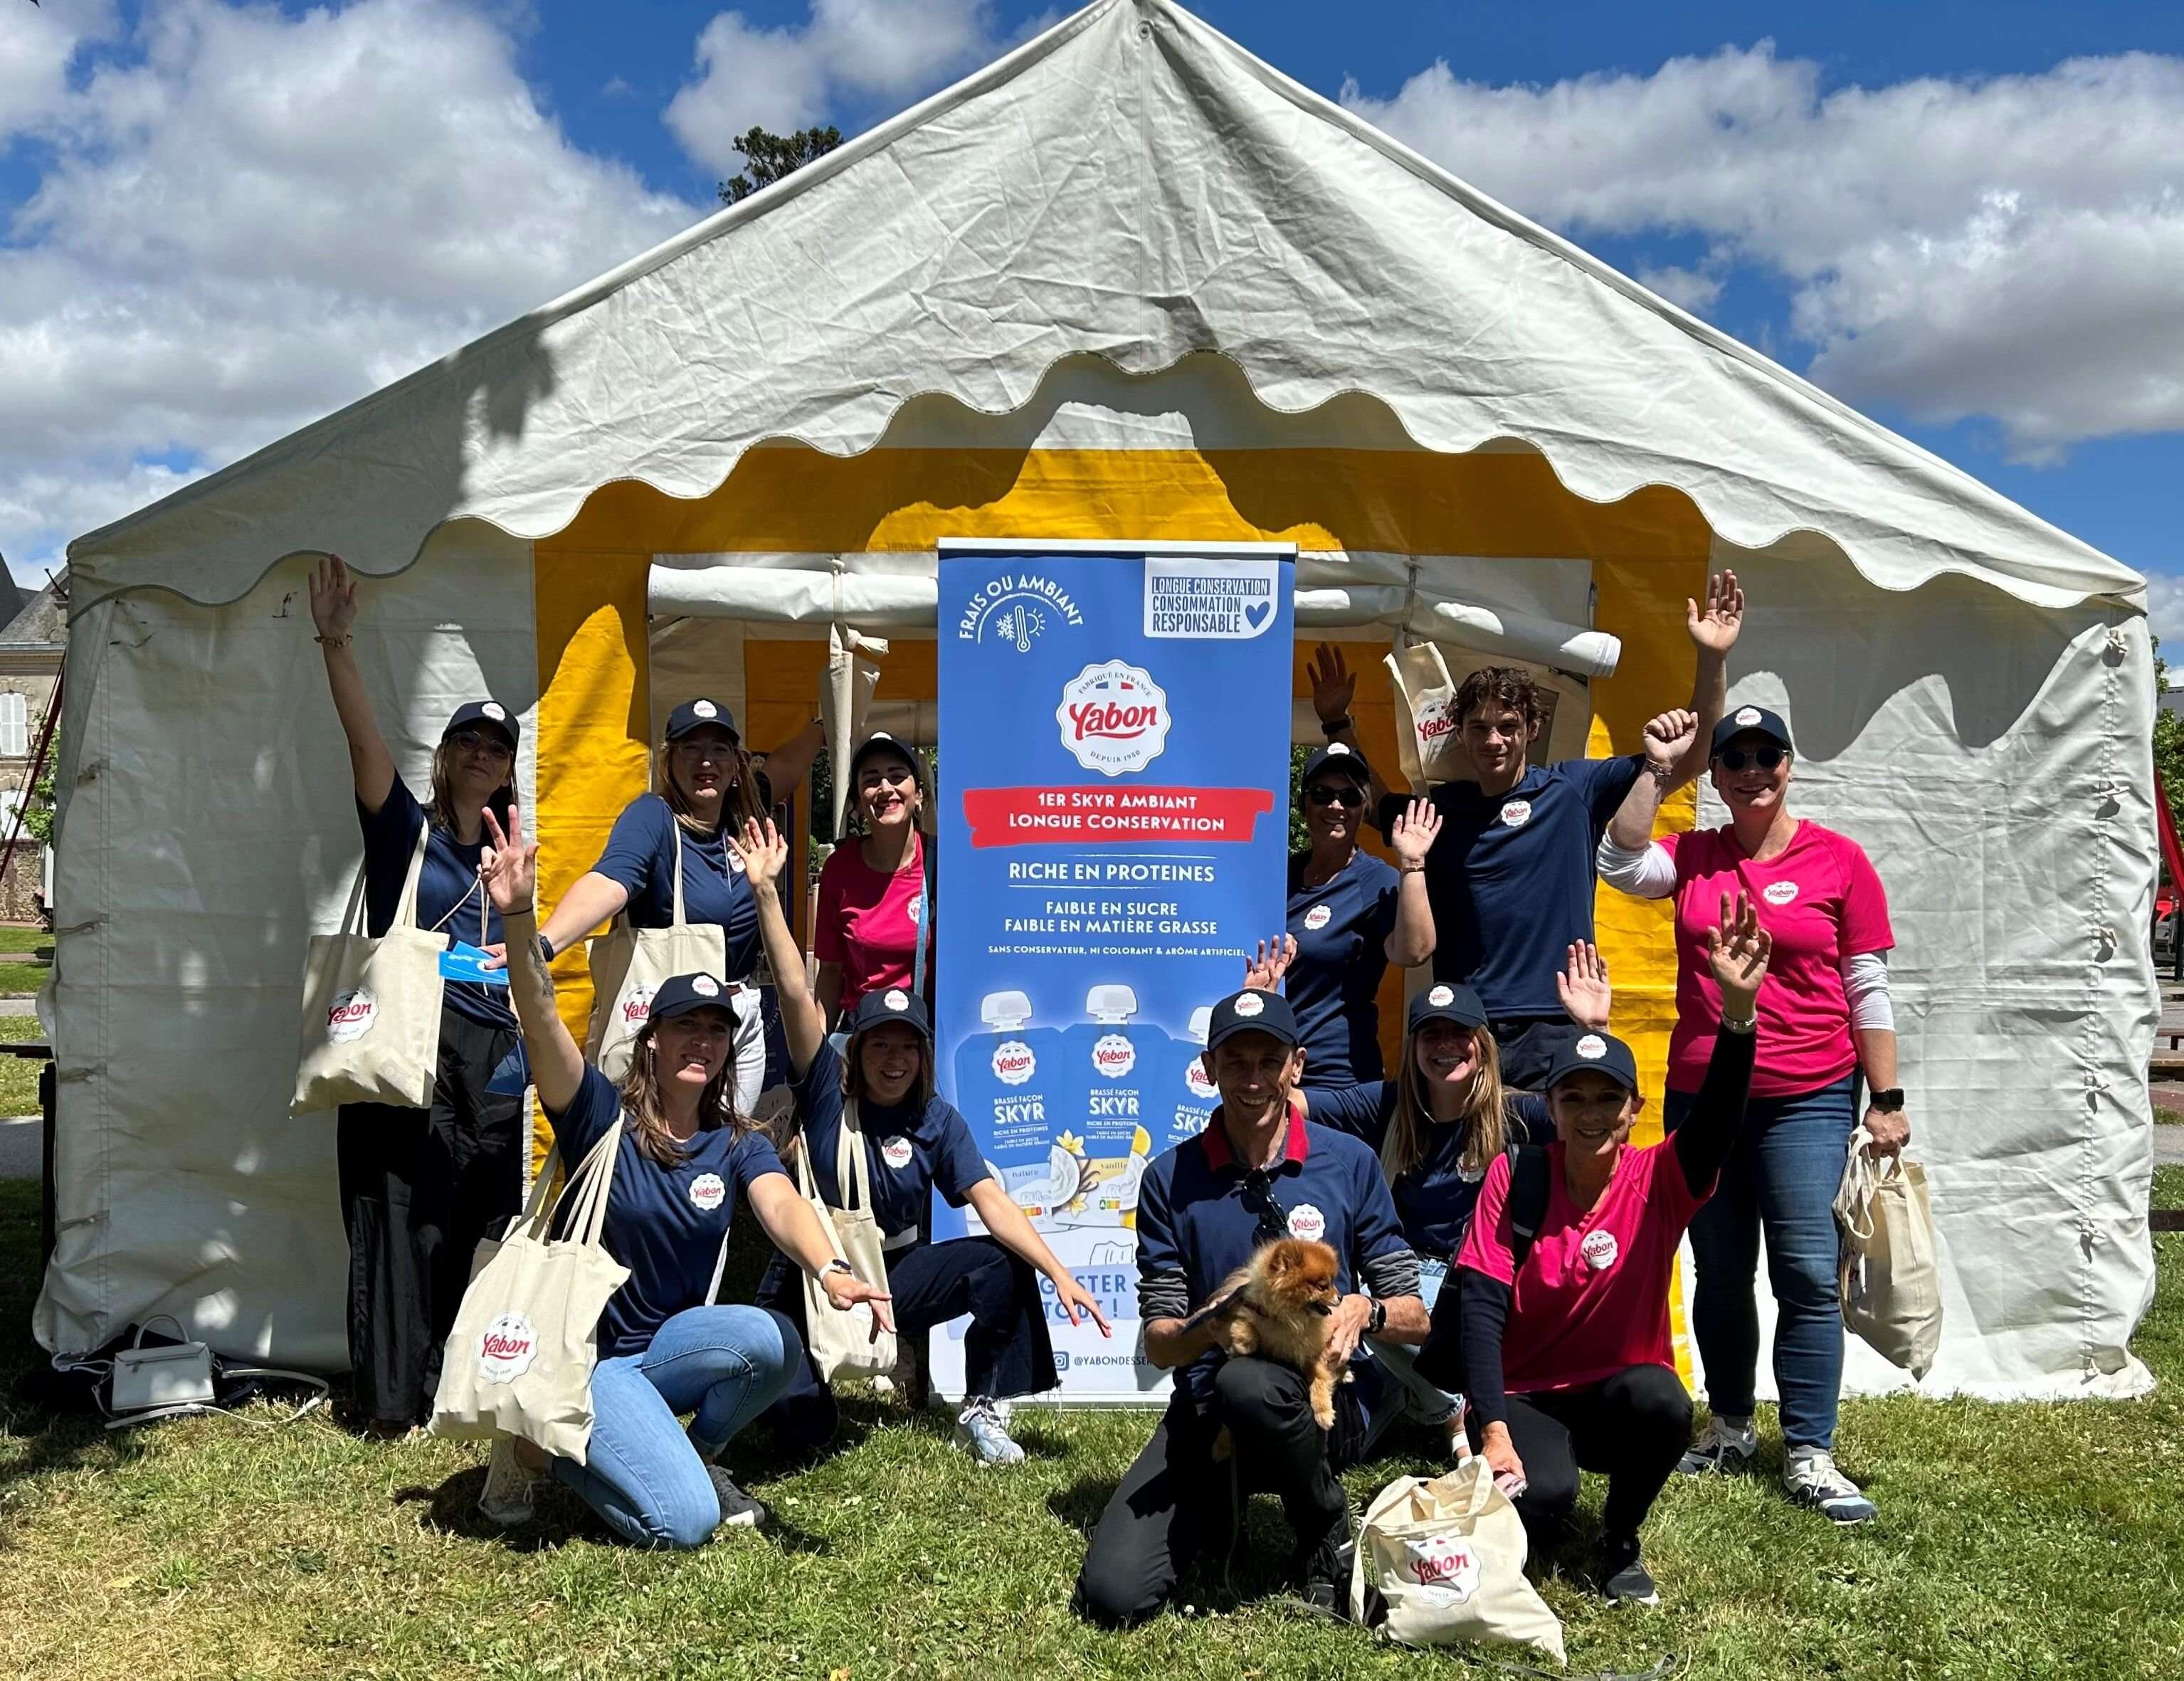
[813,734,935,1024]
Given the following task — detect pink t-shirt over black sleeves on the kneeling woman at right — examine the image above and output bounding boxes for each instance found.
[1457,1139,1706,1395]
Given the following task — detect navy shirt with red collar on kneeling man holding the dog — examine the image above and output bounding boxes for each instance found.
[1138,1109,1406,1411]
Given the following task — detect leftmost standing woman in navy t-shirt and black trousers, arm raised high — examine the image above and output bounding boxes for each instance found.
[310,554,524,1434]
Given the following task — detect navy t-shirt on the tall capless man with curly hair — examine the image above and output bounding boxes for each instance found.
[1380,753,1645,1013]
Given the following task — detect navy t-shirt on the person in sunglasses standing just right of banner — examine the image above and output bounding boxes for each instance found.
[1282,849,1402,1090]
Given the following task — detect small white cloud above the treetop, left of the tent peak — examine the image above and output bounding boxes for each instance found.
[666,0,1009,174]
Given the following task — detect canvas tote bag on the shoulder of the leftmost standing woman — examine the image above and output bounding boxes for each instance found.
[288,823,448,1116]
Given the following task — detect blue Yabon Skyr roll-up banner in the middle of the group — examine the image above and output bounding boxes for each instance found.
[932,539,1295,1401]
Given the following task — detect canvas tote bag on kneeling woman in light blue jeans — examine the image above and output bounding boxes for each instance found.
[433,1111,629,1465]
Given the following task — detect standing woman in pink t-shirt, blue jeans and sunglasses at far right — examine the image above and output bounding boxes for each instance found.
[1599,705,1911,1524]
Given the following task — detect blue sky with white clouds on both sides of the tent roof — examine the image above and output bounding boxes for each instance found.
[0,0,2184,633]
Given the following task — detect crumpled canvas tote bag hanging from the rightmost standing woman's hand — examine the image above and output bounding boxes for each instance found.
[1835,1127,1941,1378]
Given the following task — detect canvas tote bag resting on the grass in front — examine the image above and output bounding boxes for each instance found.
[1350,1454,1563,1663]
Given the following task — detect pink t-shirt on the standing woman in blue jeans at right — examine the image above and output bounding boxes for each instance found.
[1660,823,1896,1098]
